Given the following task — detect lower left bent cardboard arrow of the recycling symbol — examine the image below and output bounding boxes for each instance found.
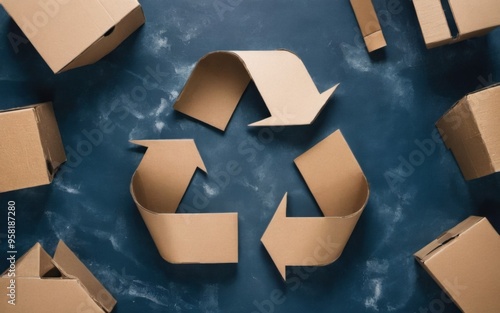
[130,140,238,264]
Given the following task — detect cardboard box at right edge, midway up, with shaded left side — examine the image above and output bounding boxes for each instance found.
[436,84,500,180]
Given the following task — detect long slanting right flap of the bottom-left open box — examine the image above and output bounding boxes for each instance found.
[54,241,116,312]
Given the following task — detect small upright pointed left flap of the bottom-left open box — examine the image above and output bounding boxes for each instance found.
[3,243,54,278]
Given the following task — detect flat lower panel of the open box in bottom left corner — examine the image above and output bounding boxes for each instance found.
[0,278,105,313]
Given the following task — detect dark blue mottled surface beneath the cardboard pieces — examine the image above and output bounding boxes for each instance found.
[0,0,500,313]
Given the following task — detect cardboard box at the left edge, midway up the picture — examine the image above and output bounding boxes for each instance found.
[0,102,66,192]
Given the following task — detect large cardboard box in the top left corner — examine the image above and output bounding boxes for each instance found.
[1,0,145,73]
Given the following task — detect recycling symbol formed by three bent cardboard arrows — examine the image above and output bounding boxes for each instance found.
[130,51,369,280]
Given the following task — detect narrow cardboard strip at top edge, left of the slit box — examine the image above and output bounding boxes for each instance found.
[351,0,387,52]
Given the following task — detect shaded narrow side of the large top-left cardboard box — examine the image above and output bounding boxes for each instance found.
[60,1,146,72]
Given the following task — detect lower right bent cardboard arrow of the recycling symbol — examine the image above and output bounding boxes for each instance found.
[261,131,369,280]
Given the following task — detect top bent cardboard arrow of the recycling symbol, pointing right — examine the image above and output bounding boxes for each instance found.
[174,50,338,131]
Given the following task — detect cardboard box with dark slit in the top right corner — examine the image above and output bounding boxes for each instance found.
[413,0,500,49]
